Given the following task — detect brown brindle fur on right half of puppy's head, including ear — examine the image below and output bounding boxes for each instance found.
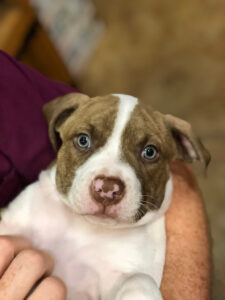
[122,104,210,219]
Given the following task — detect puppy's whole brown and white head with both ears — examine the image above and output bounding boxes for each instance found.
[44,94,209,224]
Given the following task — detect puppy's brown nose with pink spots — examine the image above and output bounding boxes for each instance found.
[91,175,125,206]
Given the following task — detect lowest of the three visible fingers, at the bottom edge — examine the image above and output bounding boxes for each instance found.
[27,276,66,300]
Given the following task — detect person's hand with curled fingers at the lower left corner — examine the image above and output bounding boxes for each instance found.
[0,236,66,300]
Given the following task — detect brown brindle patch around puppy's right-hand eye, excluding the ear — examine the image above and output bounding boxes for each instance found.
[122,105,171,219]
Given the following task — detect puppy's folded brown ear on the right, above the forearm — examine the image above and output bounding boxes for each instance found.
[165,115,211,167]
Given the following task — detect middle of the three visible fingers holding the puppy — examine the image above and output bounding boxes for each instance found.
[0,249,54,300]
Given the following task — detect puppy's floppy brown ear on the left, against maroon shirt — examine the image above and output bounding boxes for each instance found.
[43,93,90,151]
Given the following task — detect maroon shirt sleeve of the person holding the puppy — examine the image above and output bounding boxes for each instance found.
[0,51,77,207]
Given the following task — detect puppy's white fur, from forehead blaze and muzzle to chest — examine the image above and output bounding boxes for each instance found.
[0,95,172,300]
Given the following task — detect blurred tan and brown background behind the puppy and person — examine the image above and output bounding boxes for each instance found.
[0,0,225,300]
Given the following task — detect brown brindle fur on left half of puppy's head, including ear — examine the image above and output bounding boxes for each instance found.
[42,94,119,194]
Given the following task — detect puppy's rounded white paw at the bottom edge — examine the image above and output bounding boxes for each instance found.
[114,274,163,300]
